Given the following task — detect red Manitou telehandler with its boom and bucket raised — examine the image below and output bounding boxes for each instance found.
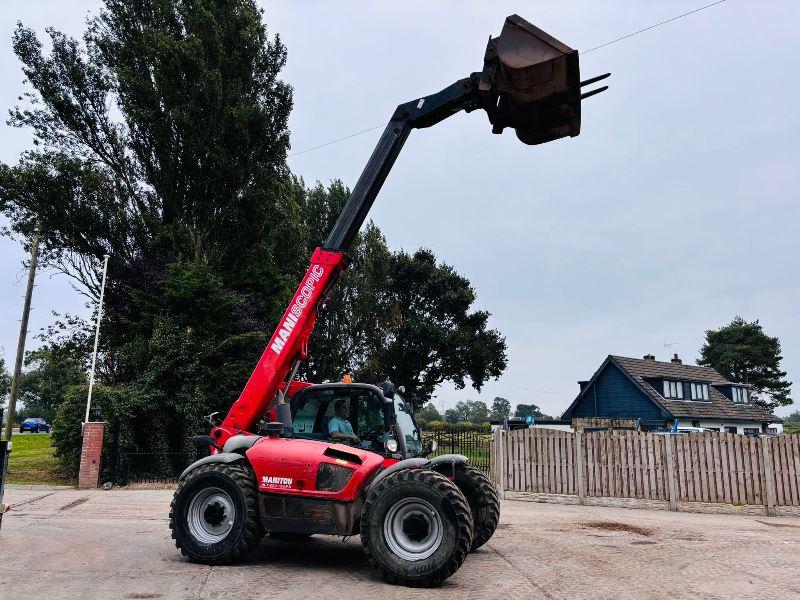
[170,15,608,586]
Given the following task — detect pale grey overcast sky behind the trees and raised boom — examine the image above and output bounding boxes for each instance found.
[0,0,800,415]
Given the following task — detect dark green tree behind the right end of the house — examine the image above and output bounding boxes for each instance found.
[697,316,792,411]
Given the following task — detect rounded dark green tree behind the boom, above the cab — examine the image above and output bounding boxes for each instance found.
[304,181,506,410]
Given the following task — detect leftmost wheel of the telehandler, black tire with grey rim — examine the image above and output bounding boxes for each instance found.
[169,463,264,565]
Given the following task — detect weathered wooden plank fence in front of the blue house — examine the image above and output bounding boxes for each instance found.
[500,429,800,507]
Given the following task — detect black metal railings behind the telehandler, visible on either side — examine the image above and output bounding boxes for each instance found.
[108,428,492,485]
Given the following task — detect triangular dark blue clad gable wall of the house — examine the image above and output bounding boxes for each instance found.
[564,360,669,420]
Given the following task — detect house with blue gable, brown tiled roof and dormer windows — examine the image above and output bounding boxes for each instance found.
[562,354,783,435]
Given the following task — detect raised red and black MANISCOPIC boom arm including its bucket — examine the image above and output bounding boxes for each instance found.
[212,15,607,446]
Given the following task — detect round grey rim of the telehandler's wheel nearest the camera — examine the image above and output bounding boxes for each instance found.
[383,498,444,561]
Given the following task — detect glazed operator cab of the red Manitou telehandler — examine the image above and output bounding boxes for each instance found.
[290,383,422,456]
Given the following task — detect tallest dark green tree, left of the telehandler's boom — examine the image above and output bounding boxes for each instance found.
[0,0,308,464]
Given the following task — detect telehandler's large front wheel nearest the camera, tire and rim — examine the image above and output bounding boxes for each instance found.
[361,469,472,587]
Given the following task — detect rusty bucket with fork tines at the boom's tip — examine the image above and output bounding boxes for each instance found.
[478,15,608,144]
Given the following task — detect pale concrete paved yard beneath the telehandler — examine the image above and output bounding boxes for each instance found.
[0,488,800,600]
